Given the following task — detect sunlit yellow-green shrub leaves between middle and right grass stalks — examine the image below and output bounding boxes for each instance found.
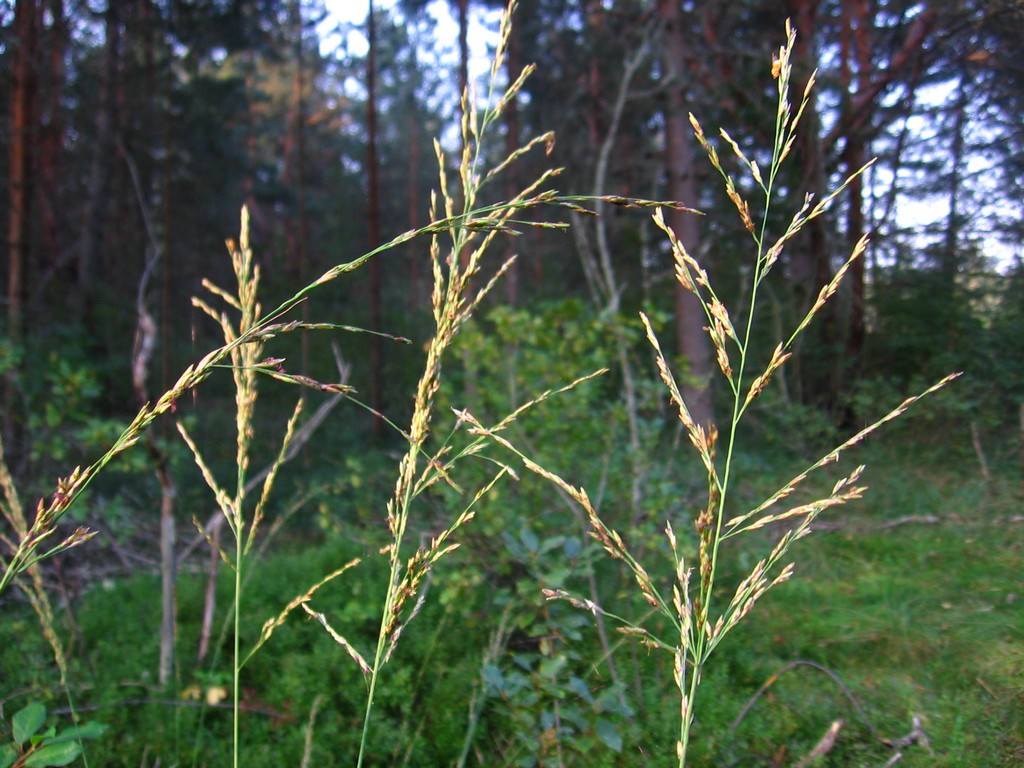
[442,299,634,514]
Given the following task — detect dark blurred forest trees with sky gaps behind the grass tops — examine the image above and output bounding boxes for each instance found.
[0,0,1024,469]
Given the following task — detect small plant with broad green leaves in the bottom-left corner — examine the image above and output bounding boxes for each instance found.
[0,701,106,768]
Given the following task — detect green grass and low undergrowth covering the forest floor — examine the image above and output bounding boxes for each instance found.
[0,462,1024,768]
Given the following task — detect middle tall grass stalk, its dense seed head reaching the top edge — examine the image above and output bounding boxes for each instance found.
[335,2,585,767]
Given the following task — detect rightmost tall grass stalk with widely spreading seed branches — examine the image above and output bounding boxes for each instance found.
[464,23,956,768]
